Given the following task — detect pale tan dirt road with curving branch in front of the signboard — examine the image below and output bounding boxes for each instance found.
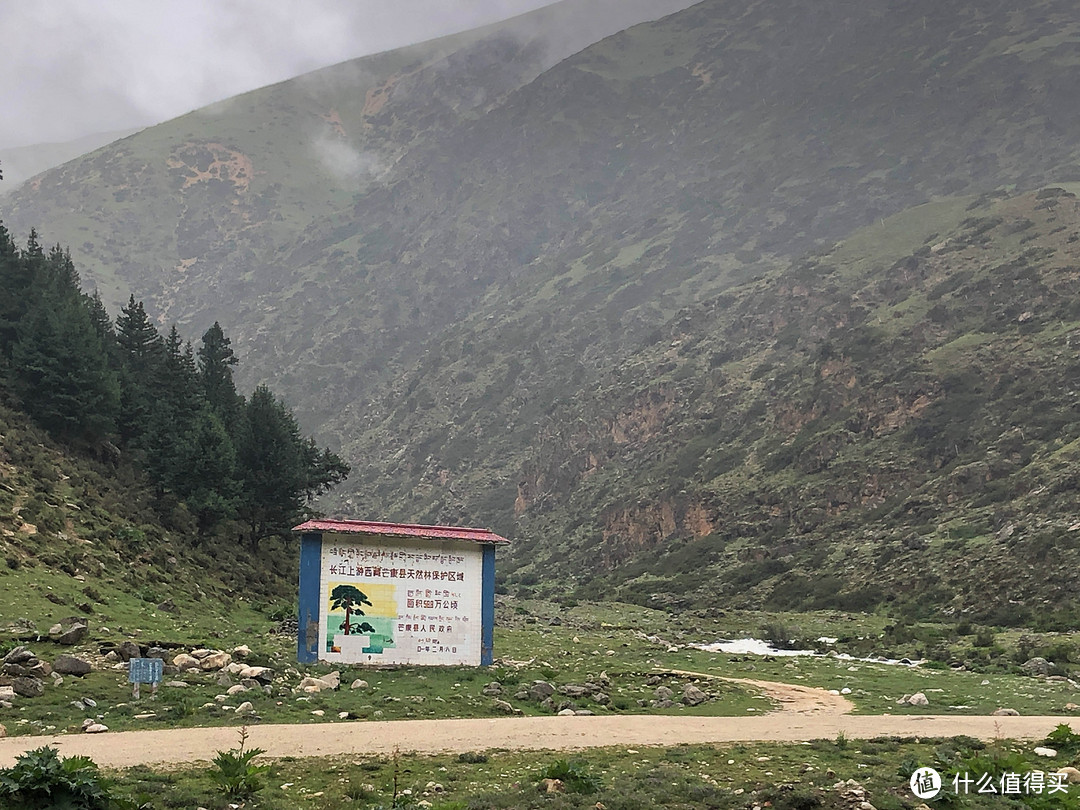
[0,679,1080,768]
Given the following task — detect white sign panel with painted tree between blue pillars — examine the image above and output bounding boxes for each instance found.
[319,535,483,665]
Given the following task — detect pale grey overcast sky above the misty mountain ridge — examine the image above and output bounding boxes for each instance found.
[0,0,574,148]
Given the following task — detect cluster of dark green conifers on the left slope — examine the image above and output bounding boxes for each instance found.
[0,225,349,549]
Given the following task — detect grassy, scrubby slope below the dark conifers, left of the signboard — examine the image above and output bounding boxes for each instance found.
[0,404,296,642]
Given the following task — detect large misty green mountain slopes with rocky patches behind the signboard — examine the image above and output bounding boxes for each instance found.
[0,0,1080,622]
